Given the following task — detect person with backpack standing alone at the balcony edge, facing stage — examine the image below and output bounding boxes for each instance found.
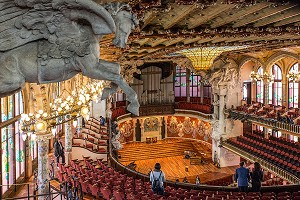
[150,163,165,195]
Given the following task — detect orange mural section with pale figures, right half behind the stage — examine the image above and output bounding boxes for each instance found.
[167,116,212,143]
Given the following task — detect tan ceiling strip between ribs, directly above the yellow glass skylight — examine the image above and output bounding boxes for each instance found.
[188,4,234,29]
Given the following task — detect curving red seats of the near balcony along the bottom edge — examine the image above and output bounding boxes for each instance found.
[58,158,300,200]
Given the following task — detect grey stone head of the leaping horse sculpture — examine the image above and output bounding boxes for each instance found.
[105,2,139,48]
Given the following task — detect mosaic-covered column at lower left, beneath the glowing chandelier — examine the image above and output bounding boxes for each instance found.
[36,133,53,200]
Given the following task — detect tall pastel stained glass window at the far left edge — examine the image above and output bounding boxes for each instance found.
[0,92,25,194]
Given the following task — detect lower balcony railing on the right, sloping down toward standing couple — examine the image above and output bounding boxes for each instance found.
[222,142,300,184]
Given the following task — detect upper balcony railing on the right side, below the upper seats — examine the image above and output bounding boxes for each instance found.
[228,110,300,137]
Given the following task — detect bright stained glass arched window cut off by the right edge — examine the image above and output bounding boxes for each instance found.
[288,63,299,108]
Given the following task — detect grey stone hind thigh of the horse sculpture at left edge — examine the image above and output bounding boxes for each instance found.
[0,55,25,97]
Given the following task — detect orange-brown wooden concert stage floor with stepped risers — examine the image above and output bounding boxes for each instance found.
[119,139,238,185]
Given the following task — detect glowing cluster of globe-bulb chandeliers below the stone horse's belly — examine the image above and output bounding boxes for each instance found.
[20,80,103,141]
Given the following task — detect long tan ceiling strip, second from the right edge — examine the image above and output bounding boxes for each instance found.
[233,4,298,28]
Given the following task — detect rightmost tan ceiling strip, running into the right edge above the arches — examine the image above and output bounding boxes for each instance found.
[254,6,300,27]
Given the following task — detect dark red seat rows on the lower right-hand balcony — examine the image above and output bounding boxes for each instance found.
[227,133,300,177]
